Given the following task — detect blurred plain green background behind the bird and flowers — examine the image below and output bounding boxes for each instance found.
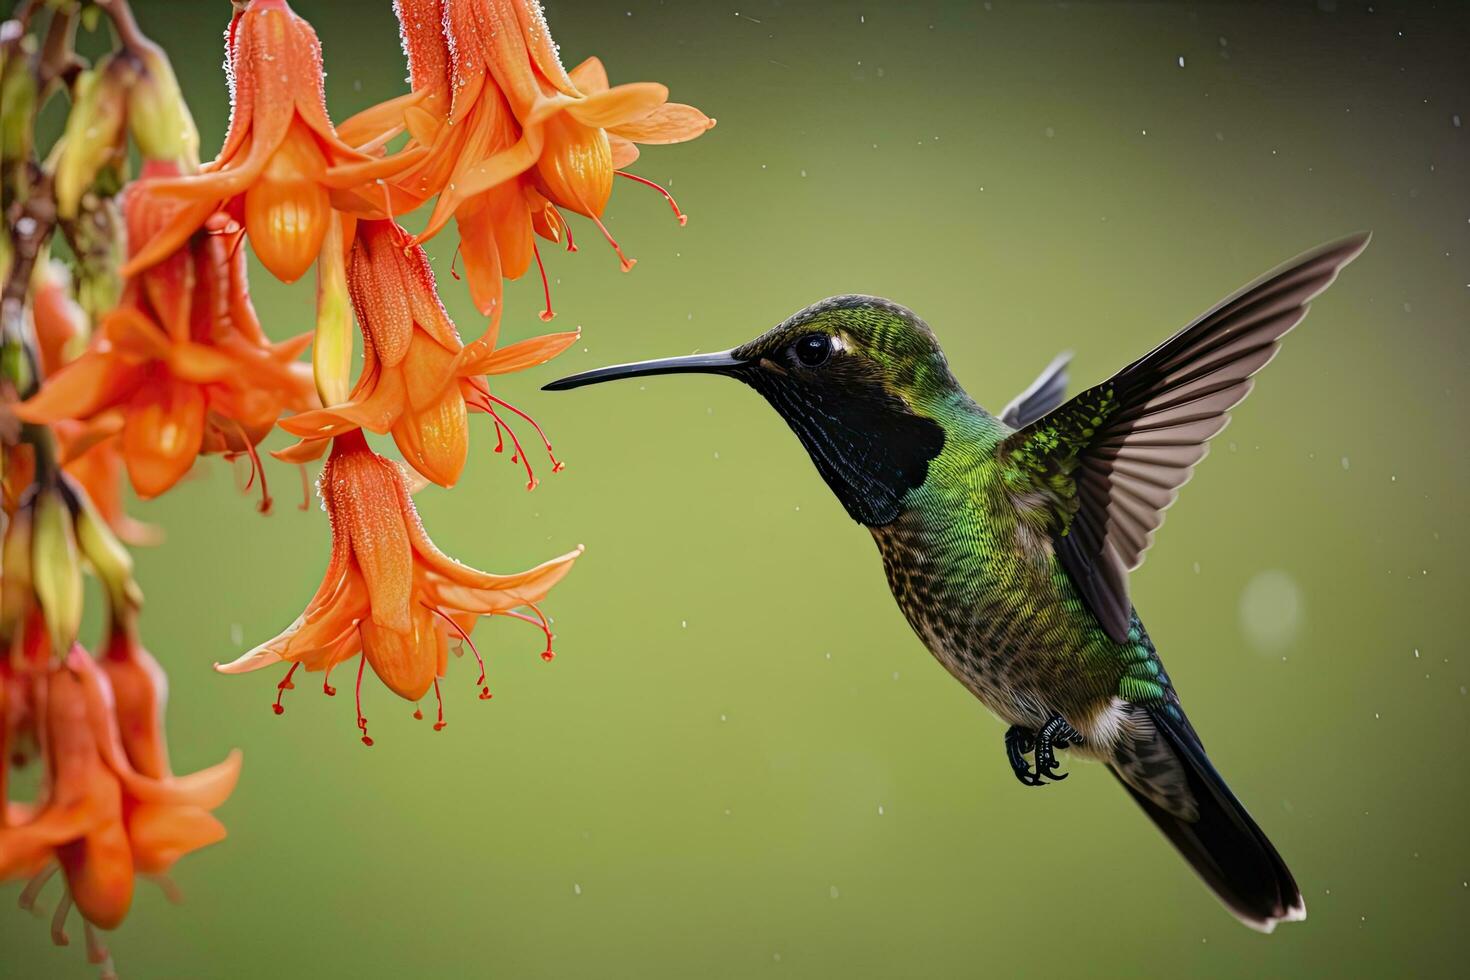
[0,0,1470,977]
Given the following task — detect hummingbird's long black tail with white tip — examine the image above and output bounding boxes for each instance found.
[1110,710,1307,933]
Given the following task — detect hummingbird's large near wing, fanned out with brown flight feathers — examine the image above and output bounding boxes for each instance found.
[1000,234,1369,642]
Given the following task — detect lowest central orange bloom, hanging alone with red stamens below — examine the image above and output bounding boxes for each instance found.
[216,430,582,745]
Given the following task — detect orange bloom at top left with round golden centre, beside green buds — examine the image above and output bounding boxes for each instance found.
[123,0,420,282]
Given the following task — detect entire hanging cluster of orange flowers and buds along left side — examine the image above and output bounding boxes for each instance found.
[0,0,714,976]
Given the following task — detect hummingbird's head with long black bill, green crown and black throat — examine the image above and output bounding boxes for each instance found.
[545,295,961,527]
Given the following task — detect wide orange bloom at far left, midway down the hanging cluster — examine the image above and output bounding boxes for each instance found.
[16,174,313,508]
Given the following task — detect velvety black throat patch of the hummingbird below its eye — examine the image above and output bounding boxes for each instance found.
[736,370,944,527]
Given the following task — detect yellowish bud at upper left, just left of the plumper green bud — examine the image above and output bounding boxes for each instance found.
[56,54,138,220]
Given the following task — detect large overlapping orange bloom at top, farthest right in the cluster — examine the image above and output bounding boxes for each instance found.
[343,0,714,320]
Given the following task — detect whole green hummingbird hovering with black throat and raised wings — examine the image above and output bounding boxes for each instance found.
[545,234,1369,932]
